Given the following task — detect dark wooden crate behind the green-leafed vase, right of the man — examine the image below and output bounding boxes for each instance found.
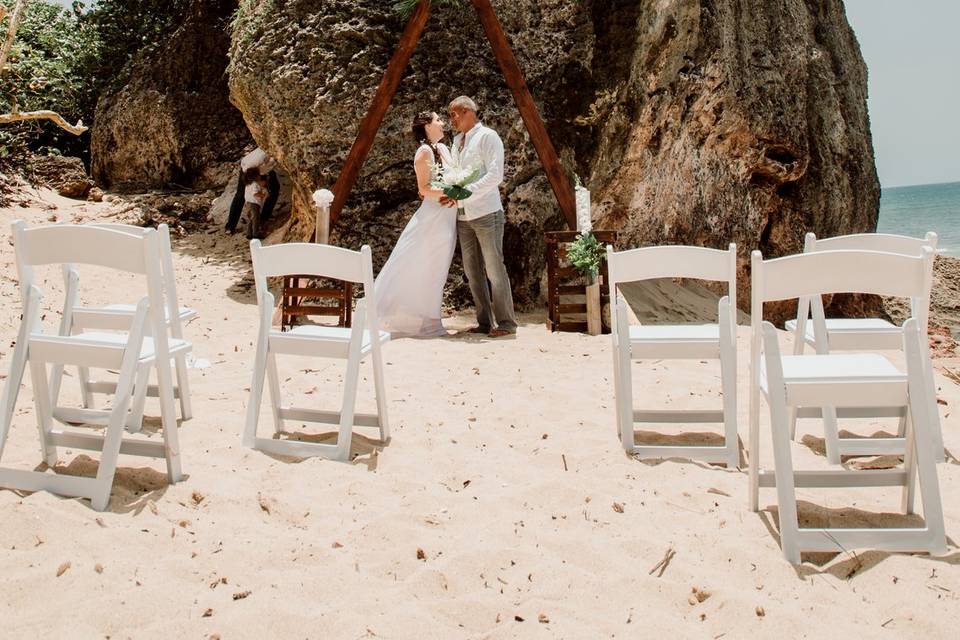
[544,230,617,333]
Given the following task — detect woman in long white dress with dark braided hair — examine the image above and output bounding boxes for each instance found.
[373,111,457,337]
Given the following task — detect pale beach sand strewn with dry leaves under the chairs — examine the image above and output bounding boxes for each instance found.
[0,192,960,640]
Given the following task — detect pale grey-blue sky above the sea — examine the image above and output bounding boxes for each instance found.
[48,0,960,187]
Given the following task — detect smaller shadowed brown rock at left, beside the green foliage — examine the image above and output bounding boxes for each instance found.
[90,0,251,190]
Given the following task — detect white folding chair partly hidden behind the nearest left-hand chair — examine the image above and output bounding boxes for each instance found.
[50,223,198,432]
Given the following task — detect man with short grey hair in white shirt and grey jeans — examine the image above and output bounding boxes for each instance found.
[441,96,517,338]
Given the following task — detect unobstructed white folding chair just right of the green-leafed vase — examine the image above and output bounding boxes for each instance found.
[607,244,739,468]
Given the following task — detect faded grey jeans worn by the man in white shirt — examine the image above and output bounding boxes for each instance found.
[457,210,517,332]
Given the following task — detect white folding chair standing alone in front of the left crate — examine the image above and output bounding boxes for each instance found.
[243,240,390,460]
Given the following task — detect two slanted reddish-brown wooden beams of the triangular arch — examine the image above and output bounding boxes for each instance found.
[326,0,577,240]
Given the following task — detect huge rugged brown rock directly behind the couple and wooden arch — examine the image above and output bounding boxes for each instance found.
[230,0,879,306]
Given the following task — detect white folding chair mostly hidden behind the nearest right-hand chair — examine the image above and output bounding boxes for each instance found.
[785,231,945,464]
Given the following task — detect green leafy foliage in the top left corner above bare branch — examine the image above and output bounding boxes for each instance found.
[0,0,187,157]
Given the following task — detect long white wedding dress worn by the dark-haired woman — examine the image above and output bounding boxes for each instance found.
[373,144,457,338]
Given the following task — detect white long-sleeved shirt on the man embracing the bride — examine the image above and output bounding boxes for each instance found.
[453,122,503,220]
